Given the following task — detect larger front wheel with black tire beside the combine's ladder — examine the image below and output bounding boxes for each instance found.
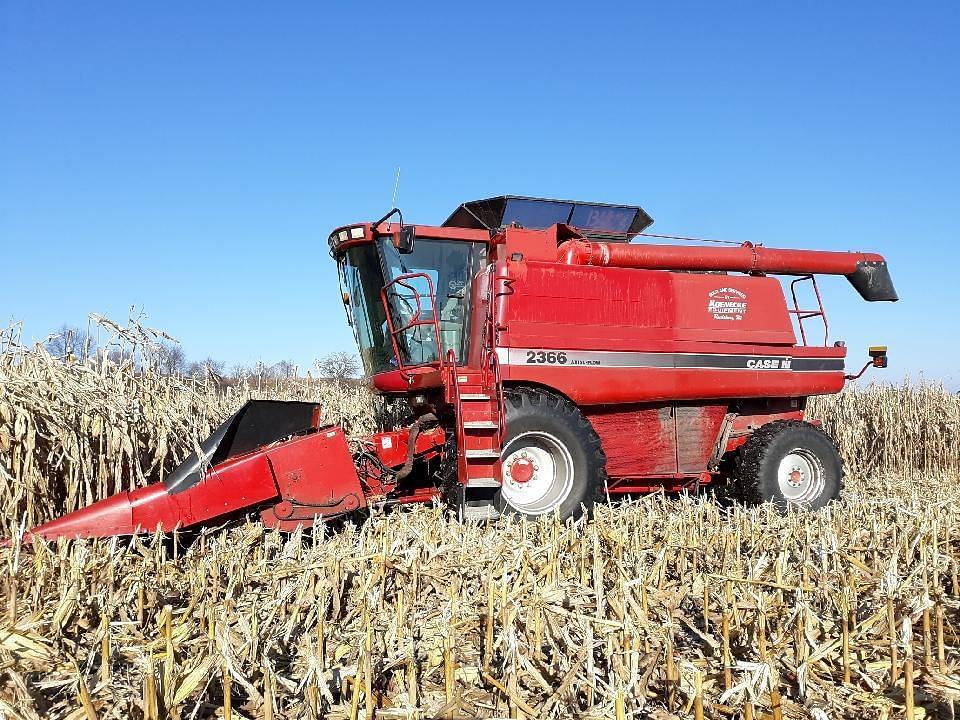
[494,388,607,519]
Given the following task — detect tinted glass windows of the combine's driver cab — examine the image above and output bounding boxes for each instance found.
[341,237,487,375]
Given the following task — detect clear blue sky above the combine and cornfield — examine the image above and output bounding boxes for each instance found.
[0,0,960,386]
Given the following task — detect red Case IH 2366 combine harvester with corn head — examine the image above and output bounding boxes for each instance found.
[32,197,897,538]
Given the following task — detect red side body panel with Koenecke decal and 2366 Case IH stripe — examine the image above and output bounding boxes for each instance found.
[497,262,846,405]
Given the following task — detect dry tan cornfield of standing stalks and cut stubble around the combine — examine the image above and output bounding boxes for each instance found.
[0,324,960,720]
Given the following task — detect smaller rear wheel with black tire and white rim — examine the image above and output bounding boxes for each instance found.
[735,420,843,510]
